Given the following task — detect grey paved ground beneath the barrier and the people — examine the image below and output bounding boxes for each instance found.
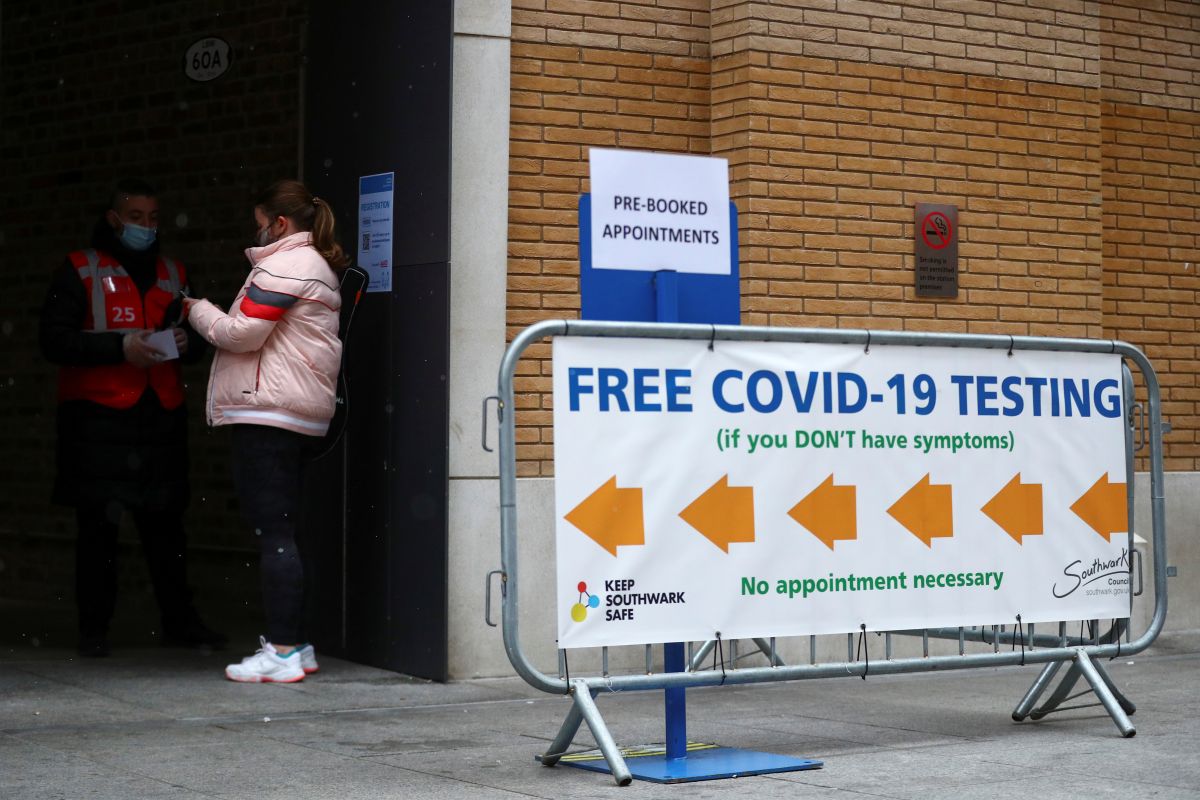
[0,632,1200,800]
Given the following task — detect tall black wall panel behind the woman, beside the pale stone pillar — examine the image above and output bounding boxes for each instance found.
[304,0,452,680]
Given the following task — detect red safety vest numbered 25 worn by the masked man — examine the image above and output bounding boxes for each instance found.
[59,249,187,409]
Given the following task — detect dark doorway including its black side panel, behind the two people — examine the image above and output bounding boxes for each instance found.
[0,0,452,679]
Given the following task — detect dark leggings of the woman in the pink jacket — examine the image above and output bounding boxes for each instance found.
[233,425,313,644]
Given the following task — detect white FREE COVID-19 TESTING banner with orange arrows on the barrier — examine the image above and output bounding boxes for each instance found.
[553,337,1129,646]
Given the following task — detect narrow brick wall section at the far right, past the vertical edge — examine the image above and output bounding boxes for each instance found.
[1100,0,1200,470]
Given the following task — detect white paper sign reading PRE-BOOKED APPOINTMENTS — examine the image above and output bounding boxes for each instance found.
[588,148,731,275]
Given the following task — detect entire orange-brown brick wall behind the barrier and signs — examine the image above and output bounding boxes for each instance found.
[509,0,1185,475]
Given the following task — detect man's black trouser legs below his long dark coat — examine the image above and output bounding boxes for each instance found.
[76,501,192,637]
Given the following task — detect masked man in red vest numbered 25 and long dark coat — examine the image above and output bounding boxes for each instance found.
[40,180,226,656]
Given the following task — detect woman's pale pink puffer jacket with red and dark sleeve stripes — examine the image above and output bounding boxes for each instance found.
[188,233,342,437]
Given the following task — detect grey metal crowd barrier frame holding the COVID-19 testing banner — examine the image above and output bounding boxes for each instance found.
[485,320,1168,786]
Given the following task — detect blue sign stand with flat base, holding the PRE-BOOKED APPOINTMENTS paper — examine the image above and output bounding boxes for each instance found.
[562,194,821,783]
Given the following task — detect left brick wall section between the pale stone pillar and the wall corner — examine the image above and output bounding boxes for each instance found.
[508,0,709,476]
